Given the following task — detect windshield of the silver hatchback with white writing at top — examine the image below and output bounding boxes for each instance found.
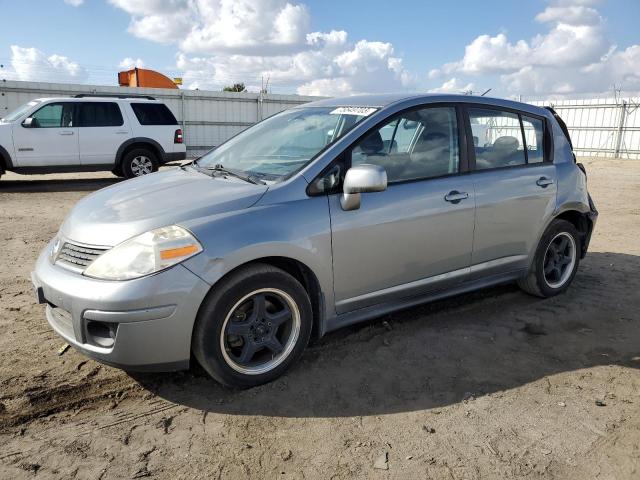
[196,107,376,182]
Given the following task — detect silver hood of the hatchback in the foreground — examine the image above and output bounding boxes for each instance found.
[60,167,268,246]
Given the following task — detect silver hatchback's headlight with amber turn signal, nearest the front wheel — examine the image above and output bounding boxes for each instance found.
[84,225,202,280]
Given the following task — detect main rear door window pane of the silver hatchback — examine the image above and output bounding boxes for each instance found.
[469,108,526,170]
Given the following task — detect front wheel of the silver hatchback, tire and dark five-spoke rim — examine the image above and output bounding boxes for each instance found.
[192,264,313,388]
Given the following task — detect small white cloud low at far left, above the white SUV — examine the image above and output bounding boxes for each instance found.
[7,45,88,83]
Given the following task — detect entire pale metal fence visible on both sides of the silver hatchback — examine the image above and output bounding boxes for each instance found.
[0,80,640,159]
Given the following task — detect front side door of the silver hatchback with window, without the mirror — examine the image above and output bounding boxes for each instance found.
[329,106,475,314]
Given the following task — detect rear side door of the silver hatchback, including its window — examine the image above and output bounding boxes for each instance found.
[466,105,557,279]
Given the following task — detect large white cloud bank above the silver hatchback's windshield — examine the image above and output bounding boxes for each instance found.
[110,0,415,95]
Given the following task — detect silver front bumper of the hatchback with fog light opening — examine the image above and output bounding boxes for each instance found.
[31,245,210,370]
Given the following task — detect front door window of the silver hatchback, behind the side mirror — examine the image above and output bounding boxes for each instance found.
[351,107,460,182]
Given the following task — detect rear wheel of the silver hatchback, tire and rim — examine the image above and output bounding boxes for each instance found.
[518,220,581,298]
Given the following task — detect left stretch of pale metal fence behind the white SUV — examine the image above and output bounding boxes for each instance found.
[0,80,319,157]
